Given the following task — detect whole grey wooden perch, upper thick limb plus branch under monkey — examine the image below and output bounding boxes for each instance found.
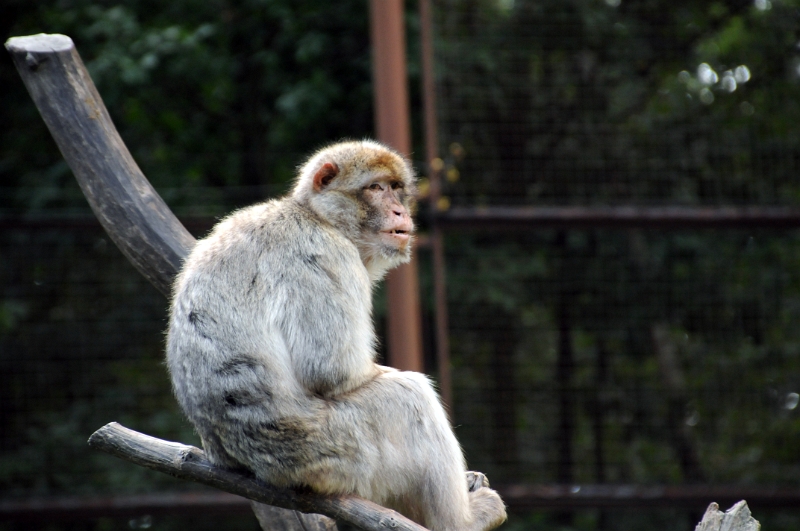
[5,34,424,531]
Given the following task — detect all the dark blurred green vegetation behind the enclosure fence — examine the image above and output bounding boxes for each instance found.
[0,0,800,531]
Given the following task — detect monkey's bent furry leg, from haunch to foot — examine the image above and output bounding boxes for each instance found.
[209,369,505,531]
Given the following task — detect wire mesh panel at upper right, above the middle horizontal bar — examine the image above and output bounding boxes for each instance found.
[434,0,800,205]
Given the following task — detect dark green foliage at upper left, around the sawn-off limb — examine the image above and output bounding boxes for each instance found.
[0,0,372,218]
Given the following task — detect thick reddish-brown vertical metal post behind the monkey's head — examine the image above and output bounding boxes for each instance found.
[370,0,423,372]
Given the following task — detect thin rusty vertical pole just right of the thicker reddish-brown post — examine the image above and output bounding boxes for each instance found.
[419,0,453,407]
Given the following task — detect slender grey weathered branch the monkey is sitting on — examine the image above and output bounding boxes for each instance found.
[89,422,425,531]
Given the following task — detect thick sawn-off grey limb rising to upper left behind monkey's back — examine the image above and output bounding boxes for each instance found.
[6,35,195,295]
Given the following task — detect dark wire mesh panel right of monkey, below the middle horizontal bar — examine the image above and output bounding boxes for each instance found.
[440,231,800,486]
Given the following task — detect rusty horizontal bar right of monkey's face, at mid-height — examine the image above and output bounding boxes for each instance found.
[434,206,800,230]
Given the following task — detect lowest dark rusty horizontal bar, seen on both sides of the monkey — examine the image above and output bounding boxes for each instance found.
[0,484,800,521]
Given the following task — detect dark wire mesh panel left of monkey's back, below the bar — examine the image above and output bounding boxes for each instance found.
[0,224,198,497]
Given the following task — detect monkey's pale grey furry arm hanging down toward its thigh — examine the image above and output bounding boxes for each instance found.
[263,218,378,396]
